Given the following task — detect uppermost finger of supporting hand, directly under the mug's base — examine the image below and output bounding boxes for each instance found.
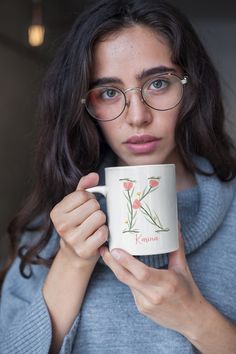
[111,248,167,284]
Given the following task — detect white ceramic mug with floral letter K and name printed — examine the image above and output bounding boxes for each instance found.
[87,164,179,255]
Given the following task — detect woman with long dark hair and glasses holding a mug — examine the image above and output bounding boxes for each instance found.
[1,0,236,354]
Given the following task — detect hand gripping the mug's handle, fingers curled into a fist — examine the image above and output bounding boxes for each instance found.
[50,173,108,265]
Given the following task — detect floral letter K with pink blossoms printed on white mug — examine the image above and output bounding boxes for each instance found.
[120,177,169,233]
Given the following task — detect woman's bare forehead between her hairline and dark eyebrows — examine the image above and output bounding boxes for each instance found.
[92,25,175,79]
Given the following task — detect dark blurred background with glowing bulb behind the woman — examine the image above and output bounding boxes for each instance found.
[0,0,236,265]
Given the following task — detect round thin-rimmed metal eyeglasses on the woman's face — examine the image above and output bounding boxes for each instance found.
[81,73,188,121]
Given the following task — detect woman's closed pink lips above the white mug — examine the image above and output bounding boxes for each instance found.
[125,135,161,154]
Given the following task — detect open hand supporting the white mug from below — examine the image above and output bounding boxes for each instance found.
[100,235,206,336]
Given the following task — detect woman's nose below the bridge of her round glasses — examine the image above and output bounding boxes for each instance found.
[125,87,152,126]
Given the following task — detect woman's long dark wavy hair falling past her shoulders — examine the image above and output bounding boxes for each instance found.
[1,0,236,280]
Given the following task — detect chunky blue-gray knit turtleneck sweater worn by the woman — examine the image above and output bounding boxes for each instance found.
[0,158,236,354]
